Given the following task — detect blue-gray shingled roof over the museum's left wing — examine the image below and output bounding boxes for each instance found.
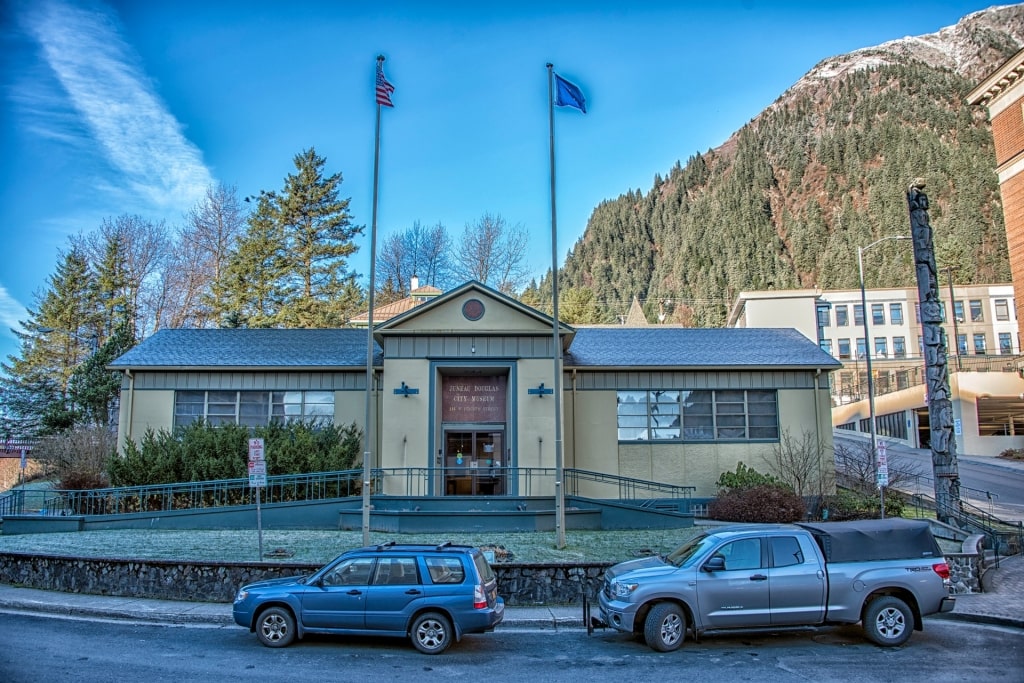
[111,330,383,369]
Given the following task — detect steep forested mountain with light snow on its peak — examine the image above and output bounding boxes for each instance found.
[524,5,1024,327]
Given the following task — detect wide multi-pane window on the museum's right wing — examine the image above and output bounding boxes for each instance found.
[617,389,779,441]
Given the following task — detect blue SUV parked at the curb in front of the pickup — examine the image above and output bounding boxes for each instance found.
[232,542,505,654]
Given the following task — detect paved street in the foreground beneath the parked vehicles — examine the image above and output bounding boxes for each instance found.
[0,613,1024,683]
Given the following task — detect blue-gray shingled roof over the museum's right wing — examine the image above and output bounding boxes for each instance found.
[564,327,842,369]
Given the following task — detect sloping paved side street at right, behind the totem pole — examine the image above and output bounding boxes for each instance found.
[836,434,1024,521]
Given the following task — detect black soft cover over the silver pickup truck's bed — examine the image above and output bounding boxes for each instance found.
[798,517,942,562]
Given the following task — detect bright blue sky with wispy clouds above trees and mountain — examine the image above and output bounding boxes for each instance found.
[0,0,1007,357]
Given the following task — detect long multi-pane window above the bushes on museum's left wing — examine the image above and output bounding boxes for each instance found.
[174,389,334,427]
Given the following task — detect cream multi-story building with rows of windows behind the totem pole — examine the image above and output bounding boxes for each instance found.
[730,283,1024,455]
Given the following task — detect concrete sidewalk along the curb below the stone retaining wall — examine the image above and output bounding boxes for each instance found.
[0,555,1024,631]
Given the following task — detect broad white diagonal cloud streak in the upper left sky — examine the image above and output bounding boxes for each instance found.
[26,0,213,208]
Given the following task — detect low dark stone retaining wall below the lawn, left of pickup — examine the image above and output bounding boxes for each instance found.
[0,553,609,606]
